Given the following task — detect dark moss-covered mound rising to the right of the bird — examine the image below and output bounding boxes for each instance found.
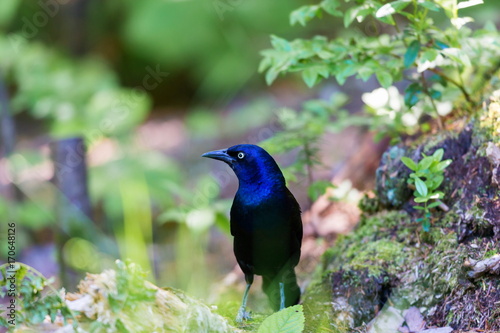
[304,94,500,332]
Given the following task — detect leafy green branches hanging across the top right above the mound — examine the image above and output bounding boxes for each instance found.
[259,0,500,136]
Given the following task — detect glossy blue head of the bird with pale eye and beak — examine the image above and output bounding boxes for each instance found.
[201,144,285,186]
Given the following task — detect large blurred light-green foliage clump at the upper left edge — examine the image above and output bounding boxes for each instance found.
[0,34,151,142]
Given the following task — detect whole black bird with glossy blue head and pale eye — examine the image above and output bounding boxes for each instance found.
[202,144,302,322]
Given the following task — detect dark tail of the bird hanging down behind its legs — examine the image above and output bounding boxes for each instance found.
[262,268,300,311]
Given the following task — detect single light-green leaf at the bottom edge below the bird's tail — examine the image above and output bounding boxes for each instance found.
[257,305,305,333]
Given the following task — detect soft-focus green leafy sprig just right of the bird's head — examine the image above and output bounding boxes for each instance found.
[260,94,349,200]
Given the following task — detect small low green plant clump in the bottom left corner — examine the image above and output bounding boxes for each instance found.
[0,263,77,327]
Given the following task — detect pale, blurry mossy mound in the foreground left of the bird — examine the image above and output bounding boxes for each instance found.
[7,260,243,333]
